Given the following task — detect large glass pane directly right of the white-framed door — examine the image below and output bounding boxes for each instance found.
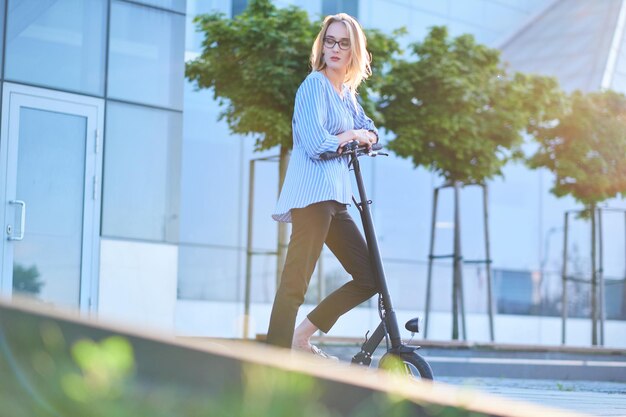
[102,102,182,242]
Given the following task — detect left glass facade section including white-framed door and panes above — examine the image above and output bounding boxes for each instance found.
[0,0,186,327]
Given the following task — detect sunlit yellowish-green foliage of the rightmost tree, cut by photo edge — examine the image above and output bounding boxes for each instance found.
[529,91,626,206]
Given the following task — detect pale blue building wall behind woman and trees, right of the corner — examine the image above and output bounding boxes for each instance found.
[176,0,623,343]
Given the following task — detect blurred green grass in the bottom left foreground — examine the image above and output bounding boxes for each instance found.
[0,320,478,417]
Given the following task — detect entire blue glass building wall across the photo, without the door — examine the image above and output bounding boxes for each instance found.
[0,0,626,343]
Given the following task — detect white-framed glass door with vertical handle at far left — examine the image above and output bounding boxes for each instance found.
[0,83,103,310]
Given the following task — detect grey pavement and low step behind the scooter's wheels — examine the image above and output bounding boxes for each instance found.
[319,338,626,417]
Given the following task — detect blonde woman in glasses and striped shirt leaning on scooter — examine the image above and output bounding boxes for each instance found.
[267,13,378,359]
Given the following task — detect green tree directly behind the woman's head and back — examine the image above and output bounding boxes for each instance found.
[186,0,398,282]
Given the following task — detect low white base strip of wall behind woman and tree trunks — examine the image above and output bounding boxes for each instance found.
[175,300,626,353]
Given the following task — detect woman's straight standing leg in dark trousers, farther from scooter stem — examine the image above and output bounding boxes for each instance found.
[267,201,337,348]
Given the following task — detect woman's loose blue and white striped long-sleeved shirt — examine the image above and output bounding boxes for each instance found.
[272,71,377,222]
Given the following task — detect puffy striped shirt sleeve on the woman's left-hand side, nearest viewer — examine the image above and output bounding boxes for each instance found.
[292,78,339,159]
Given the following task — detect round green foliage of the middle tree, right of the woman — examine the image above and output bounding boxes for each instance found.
[379,27,561,183]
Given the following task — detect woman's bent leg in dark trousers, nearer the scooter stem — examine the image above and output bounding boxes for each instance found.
[308,208,377,333]
